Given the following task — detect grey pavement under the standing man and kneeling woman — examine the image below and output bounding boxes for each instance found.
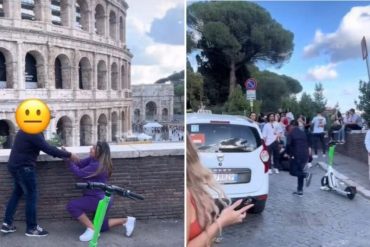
[0,219,184,247]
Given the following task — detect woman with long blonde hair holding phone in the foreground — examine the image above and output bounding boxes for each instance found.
[186,136,253,247]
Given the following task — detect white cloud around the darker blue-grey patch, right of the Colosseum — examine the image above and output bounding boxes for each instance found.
[126,0,185,85]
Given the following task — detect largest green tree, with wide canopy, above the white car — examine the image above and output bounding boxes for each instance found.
[187,1,293,101]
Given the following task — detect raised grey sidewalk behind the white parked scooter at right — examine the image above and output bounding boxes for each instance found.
[312,152,370,199]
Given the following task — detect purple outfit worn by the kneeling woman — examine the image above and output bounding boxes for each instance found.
[67,157,112,232]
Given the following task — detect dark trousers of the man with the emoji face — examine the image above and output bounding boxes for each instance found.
[4,166,37,230]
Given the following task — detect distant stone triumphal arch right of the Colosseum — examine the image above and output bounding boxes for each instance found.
[132,84,174,124]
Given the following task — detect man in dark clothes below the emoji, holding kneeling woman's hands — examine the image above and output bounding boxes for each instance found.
[1,130,78,237]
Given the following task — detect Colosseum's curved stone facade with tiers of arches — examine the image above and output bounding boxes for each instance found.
[0,0,132,148]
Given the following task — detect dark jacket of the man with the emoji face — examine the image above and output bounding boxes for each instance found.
[8,130,71,170]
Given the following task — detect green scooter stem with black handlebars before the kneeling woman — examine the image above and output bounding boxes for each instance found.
[76,182,144,247]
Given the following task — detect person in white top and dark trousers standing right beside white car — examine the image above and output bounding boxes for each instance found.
[262,113,280,174]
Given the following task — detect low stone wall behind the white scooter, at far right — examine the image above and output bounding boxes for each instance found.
[336,131,368,165]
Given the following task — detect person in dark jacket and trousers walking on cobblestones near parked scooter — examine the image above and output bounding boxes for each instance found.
[286,120,312,196]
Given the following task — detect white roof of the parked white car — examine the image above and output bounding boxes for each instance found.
[186,113,258,128]
